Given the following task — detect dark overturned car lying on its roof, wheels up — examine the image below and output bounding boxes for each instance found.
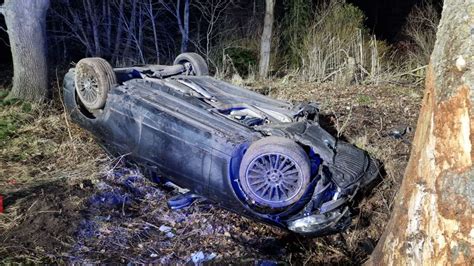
[64,53,378,235]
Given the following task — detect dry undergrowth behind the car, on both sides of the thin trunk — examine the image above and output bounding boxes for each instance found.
[206,0,439,86]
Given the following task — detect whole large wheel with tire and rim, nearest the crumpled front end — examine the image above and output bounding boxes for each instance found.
[239,137,311,209]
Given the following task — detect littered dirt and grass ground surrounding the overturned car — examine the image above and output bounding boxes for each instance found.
[0,75,422,264]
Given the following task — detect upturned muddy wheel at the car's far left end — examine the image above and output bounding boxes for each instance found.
[74,57,117,111]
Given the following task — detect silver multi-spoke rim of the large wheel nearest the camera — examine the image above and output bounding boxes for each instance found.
[245,153,304,207]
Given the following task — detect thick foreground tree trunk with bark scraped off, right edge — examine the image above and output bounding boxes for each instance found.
[369,0,474,265]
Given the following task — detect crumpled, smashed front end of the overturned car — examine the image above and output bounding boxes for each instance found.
[259,121,379,236]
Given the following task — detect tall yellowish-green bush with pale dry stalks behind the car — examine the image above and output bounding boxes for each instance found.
[301,1,387,83]
